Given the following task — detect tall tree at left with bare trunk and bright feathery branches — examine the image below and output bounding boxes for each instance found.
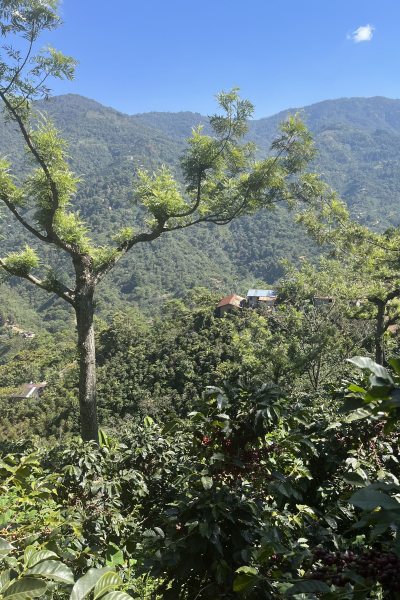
[0,0,323,440]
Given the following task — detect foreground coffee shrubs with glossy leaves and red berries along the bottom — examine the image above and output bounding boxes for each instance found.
[0,352,400,600]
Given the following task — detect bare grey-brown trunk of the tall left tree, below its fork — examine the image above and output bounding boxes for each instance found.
[75,290,99,443]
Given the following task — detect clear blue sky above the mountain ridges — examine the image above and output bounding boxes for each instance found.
[44,0,400,118]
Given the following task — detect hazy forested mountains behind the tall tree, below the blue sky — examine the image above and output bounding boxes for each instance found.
[0,94,400,331]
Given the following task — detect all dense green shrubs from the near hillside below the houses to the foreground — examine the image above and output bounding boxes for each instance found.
[0,278,400,600]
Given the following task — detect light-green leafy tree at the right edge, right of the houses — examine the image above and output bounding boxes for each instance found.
[297,191,400,365]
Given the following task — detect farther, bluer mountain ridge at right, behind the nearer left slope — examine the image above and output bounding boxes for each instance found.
[131,96,400,229]
